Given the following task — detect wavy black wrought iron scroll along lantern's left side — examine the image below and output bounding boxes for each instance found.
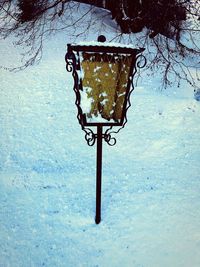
[65,45,96,146]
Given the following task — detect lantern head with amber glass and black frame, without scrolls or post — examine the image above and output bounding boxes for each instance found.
[65,44,141,126]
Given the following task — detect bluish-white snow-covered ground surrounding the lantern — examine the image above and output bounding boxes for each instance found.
[0,3,200,267]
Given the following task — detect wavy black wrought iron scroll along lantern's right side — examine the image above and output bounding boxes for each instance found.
[104,52,147,146]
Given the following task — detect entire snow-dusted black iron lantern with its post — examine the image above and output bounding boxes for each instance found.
[65,36,146,224]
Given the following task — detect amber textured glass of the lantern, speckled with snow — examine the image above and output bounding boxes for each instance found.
[80,52,133,124]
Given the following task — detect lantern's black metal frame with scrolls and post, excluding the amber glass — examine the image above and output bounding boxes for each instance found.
[65,40,146,224]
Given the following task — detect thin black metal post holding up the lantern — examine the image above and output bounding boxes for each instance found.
[95,126,102,224]
